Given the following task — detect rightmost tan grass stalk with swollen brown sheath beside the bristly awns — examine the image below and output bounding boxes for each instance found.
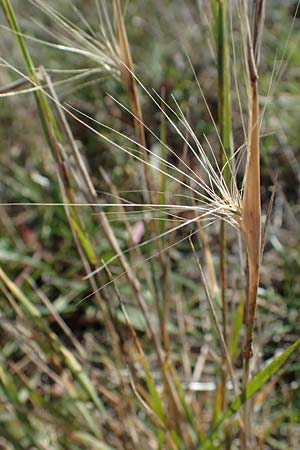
[241,0,264,449]
